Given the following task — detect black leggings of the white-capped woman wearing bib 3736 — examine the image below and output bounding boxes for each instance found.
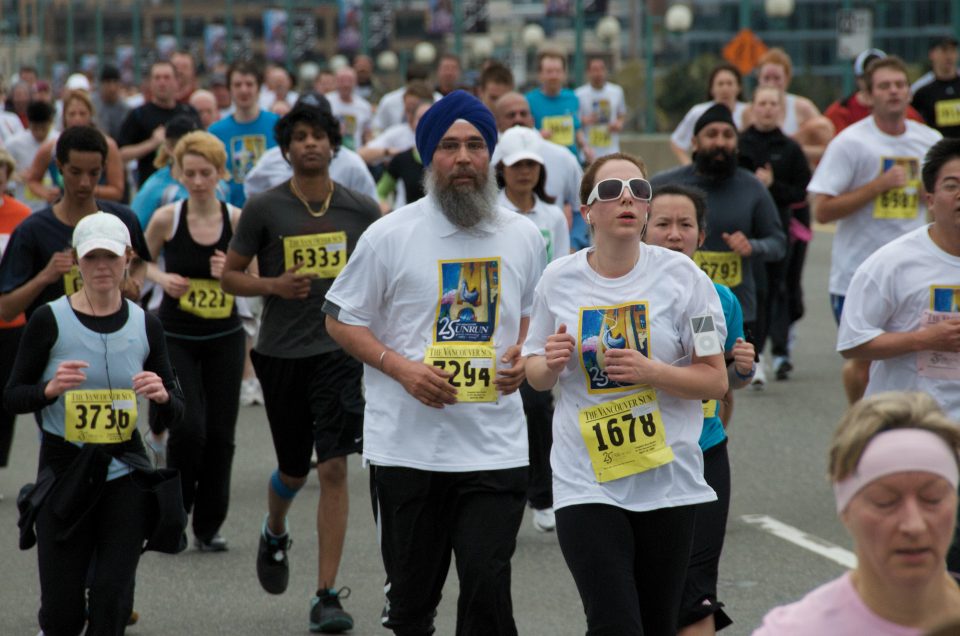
[36,476,148,636]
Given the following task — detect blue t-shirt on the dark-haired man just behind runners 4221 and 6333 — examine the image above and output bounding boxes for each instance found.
[210,110,280,208]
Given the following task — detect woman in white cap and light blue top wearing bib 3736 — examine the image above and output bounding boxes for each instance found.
[4,212,184,635]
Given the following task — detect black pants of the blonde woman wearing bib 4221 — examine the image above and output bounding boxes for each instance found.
[154,329,245,541]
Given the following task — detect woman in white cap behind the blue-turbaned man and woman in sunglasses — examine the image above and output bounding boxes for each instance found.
[495,126,570,532]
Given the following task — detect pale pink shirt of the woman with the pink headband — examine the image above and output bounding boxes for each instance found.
[753,572,923,636]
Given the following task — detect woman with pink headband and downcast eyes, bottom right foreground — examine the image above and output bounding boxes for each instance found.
[754,393,960,636]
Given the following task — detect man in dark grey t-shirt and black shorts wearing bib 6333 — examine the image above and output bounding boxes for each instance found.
[222,105,380,633]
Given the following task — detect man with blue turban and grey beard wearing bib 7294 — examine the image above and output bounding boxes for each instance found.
[323,91,546,635]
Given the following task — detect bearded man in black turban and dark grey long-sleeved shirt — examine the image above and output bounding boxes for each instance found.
[650,104,787,352]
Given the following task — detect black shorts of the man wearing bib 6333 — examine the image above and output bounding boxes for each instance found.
[250,350,364,477]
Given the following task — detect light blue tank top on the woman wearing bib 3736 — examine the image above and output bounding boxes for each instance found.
[40,296,150,481]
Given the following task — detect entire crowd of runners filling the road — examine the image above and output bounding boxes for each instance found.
[0,37,960,636]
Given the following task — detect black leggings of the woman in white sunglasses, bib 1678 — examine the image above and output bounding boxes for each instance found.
[557,504,696,636]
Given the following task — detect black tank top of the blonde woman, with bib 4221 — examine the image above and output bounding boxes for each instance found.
[159,200,240,338]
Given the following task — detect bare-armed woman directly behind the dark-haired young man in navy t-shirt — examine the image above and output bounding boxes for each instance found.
[23,90,126,203]
